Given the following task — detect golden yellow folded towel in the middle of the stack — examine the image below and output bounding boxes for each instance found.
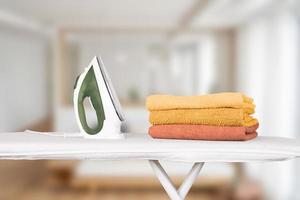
[149,108,258,127]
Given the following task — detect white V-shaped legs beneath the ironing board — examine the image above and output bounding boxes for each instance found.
[149,160,204,200]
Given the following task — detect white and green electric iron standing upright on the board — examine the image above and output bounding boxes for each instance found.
[73,57,124,139]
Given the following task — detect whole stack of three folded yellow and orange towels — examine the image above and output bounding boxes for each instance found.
[146,93,258,140]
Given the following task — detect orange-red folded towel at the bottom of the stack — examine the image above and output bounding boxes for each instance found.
[149,123,259,141]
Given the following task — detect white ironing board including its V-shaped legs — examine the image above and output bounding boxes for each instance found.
[0,132,300,200]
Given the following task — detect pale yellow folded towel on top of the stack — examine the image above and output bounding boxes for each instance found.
[146,93,255,114]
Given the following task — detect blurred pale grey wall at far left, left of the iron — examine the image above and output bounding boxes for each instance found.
[0,24,50,131]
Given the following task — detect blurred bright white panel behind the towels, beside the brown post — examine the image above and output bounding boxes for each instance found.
[198,32,234,94]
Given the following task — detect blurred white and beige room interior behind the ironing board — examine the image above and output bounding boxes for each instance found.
[0,0,300,200]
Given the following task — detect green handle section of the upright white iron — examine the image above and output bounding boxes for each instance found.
[77,67,105,135]
